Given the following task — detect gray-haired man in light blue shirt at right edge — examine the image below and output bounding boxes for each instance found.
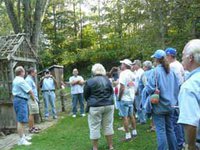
[178,39,200,150]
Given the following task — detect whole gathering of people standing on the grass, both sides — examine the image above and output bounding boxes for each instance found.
[12,39,200,150]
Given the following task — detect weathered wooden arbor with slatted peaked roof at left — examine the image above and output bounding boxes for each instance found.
[0,33,37,130]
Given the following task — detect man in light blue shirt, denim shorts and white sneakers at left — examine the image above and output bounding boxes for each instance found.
[12,66,35,145]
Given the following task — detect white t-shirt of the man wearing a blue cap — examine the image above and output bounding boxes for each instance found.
[170,60,184,85]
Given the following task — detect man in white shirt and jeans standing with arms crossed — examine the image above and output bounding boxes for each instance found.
[69,68,85,118]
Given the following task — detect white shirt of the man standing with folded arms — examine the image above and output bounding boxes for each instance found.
[69,76,84,94]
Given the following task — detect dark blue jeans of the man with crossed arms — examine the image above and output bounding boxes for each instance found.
[72,93,84,115]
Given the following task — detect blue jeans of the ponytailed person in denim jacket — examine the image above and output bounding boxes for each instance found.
[152,113,177,150]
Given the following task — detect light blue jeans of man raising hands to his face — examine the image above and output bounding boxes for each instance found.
[42,91,56,117]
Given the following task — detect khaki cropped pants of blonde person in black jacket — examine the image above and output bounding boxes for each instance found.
[88,105,114,140]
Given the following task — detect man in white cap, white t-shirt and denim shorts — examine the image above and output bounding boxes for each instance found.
[119,59,137,141]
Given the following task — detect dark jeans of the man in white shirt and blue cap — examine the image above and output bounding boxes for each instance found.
[172,109,185,150]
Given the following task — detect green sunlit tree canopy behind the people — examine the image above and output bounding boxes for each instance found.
[0,0,200,77]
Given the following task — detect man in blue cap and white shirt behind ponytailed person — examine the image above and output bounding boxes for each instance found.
[165,47,184,149]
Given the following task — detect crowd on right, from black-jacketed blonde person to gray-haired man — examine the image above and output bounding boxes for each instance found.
[84,39,200,150]
